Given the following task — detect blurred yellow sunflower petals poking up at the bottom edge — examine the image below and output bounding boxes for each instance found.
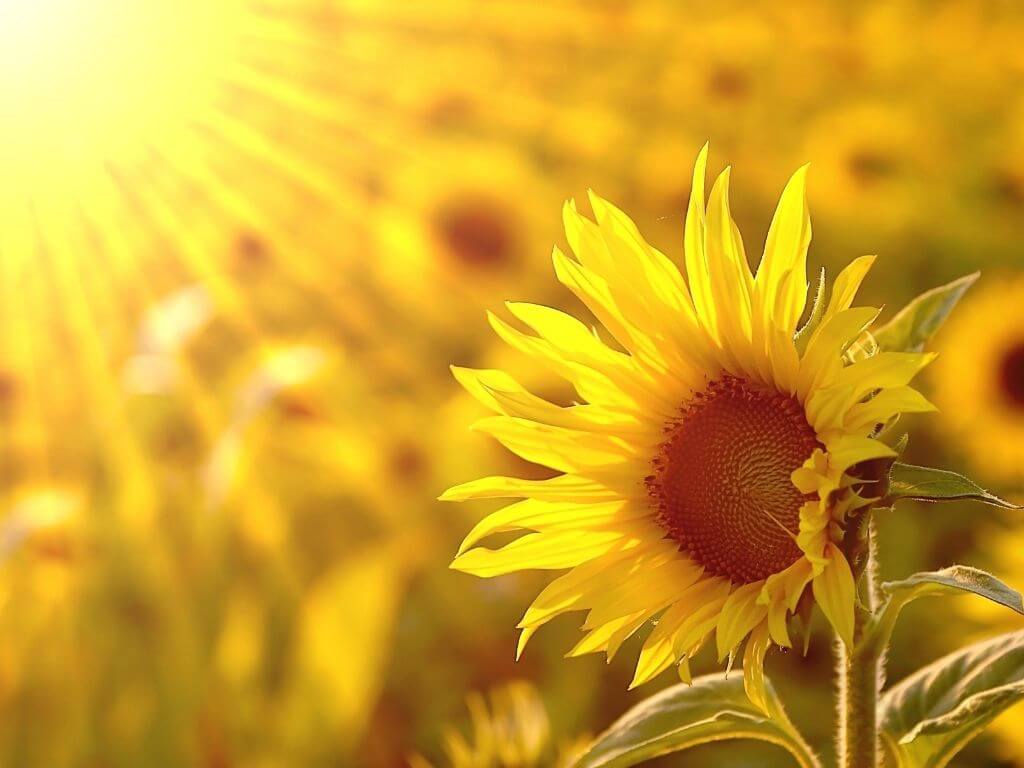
[410,681,583,768]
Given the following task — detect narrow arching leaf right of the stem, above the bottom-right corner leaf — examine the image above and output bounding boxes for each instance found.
[860,565,1024,648]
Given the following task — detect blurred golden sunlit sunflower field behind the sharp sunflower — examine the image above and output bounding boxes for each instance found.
[0,0,1024,768]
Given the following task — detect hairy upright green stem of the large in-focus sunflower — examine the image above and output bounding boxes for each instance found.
[836,521,885,768]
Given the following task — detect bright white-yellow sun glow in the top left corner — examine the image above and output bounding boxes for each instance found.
[0,0,238,193]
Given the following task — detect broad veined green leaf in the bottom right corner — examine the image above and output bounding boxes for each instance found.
[880,632,1024,768]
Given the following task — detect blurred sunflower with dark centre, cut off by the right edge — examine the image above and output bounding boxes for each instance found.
[933,275,1024,485]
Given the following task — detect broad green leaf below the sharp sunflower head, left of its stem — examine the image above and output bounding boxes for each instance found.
[574,674,818,768]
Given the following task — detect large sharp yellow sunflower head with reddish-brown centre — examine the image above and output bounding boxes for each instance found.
[441,146,933,702]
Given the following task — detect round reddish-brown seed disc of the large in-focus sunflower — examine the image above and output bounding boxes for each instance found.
[647,376,819,584]
